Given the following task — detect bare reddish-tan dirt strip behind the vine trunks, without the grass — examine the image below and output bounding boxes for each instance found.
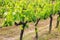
[0,15,57,40]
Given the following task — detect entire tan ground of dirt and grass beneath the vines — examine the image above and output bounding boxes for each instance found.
[0,15,60,40]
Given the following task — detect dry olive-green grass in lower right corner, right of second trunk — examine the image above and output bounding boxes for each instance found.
[39,26,60,40]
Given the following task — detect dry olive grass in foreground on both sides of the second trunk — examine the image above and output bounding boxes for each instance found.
[18,26,60,40]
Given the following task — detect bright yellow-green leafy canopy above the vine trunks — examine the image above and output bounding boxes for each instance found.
[0,0,60,25]
